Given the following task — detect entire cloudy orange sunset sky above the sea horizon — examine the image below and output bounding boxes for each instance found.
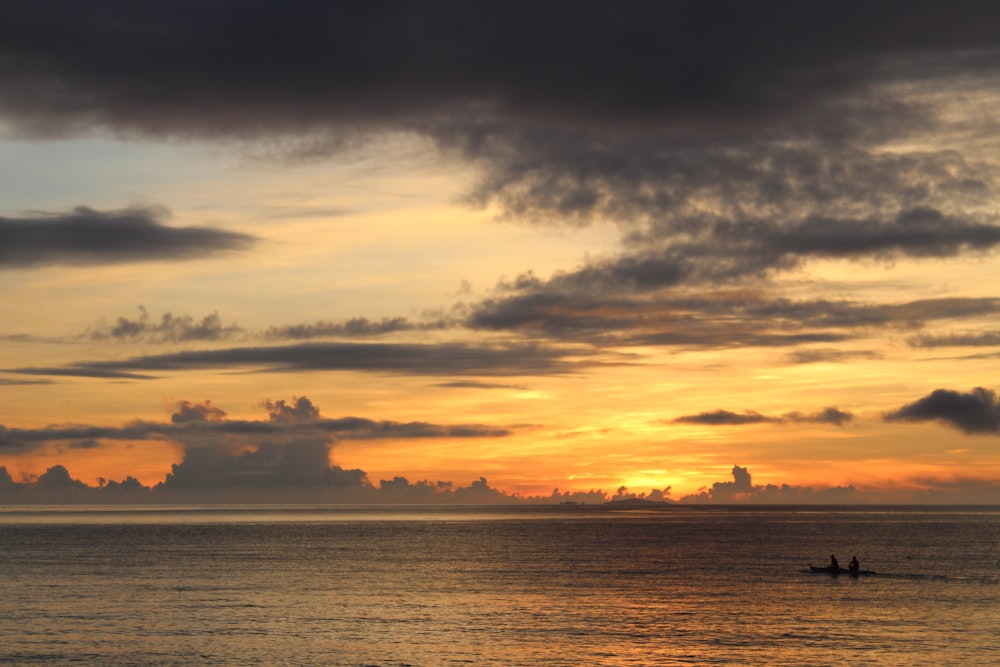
[0,0,1000,503]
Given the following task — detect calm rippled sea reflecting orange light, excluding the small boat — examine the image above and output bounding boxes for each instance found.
[0,507,1000,666]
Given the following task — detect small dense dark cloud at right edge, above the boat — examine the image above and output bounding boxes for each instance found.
[885,387,1000,435]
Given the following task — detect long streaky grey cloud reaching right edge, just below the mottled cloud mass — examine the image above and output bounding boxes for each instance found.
[465,282,1000,347]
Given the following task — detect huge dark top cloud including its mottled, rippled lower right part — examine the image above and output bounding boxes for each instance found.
[0,0,1000,288]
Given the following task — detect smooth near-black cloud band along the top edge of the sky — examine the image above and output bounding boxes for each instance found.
[0,0,1000,135]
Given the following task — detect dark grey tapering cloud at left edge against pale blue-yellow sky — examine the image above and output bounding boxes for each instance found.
[0,206,255,269]
